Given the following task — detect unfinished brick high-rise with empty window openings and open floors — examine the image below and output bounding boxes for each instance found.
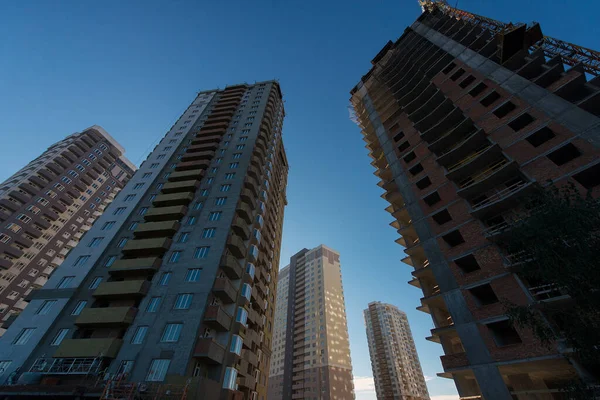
[351,1,600,399]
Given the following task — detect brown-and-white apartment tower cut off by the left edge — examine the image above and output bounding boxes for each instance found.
[0,126,136,335]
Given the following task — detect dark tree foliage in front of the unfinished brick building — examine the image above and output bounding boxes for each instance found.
[501,185,600,382]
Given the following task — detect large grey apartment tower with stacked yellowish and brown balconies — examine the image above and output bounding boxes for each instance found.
[0,81,288,400]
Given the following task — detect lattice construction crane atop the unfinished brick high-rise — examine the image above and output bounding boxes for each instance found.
[418,0,600,76]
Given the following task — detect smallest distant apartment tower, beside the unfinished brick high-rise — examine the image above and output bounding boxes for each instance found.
[364,301,429,400]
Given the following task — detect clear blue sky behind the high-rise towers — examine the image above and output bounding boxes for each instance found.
[0,0,600,400]
